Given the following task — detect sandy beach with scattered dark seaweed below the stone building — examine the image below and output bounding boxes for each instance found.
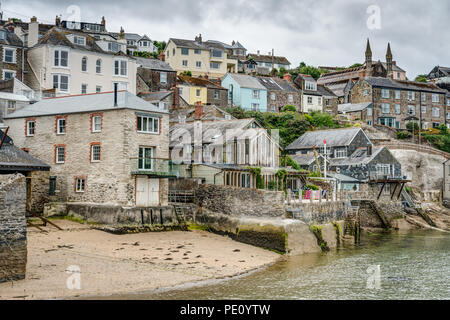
[0,220,281,300]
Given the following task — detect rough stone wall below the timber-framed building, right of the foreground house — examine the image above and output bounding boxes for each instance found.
[195,184,285,217]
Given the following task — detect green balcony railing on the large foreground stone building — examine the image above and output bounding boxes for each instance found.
[130,158,180,178]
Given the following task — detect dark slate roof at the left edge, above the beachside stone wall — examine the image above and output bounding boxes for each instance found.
[0,130,50,172]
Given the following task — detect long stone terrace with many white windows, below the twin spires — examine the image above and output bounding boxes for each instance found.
[350,77,450,129]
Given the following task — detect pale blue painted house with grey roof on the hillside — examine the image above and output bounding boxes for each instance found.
[222,73,267,112]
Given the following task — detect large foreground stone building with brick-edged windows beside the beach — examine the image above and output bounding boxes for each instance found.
[5,91,172,207]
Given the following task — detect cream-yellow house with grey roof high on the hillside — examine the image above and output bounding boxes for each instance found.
[164,35,238,79]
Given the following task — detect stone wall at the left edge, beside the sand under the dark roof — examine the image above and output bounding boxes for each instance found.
[0,174,27,282]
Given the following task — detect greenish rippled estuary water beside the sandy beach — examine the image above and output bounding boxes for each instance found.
[116,231,450,300]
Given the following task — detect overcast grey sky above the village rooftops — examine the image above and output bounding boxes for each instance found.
[1,0,450,79]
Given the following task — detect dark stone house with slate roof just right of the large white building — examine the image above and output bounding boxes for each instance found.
[135,57,177,94]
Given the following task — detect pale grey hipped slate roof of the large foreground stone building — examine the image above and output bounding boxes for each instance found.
[4,91,167,119]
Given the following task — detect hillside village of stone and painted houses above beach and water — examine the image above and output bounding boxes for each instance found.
[0,9,450,296]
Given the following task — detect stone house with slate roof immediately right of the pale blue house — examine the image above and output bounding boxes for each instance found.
[257,75,302,112]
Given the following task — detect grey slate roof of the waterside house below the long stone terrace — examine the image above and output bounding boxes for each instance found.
[286,128,368,150]
